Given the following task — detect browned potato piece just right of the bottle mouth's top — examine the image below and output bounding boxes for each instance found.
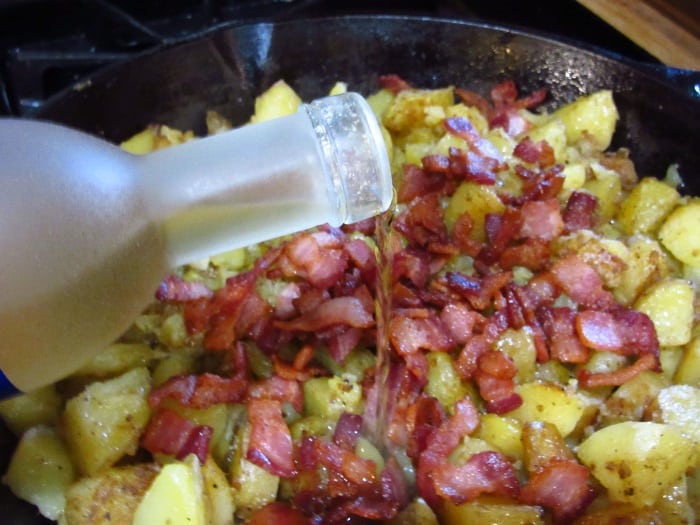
[382,87,454,133]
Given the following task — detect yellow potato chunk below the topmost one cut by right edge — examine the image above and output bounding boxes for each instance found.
[634,279,695,346]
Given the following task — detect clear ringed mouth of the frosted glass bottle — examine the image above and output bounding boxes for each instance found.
[304,93,393,224]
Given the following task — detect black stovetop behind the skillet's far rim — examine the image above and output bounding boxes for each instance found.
[0,0,656,115]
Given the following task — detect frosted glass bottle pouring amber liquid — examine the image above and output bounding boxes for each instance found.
[0,93,392,397]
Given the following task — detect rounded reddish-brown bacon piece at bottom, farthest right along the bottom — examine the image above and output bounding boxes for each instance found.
[520,459,596,523]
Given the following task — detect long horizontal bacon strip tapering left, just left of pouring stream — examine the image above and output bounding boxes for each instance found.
[274,297,374,332]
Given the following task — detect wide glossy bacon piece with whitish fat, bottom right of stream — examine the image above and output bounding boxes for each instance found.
[433,451,520,505]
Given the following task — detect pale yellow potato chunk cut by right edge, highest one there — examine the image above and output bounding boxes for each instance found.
[659,199,700,266]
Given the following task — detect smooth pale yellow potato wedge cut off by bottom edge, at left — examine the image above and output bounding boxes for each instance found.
[133,455,206,525]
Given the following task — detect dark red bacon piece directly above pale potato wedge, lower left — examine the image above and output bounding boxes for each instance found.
[141,408,214,464]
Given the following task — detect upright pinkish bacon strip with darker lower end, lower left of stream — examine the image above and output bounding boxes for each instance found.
[246,399,295,477]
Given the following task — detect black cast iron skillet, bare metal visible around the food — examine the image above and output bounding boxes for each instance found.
[0,16,700,525]
